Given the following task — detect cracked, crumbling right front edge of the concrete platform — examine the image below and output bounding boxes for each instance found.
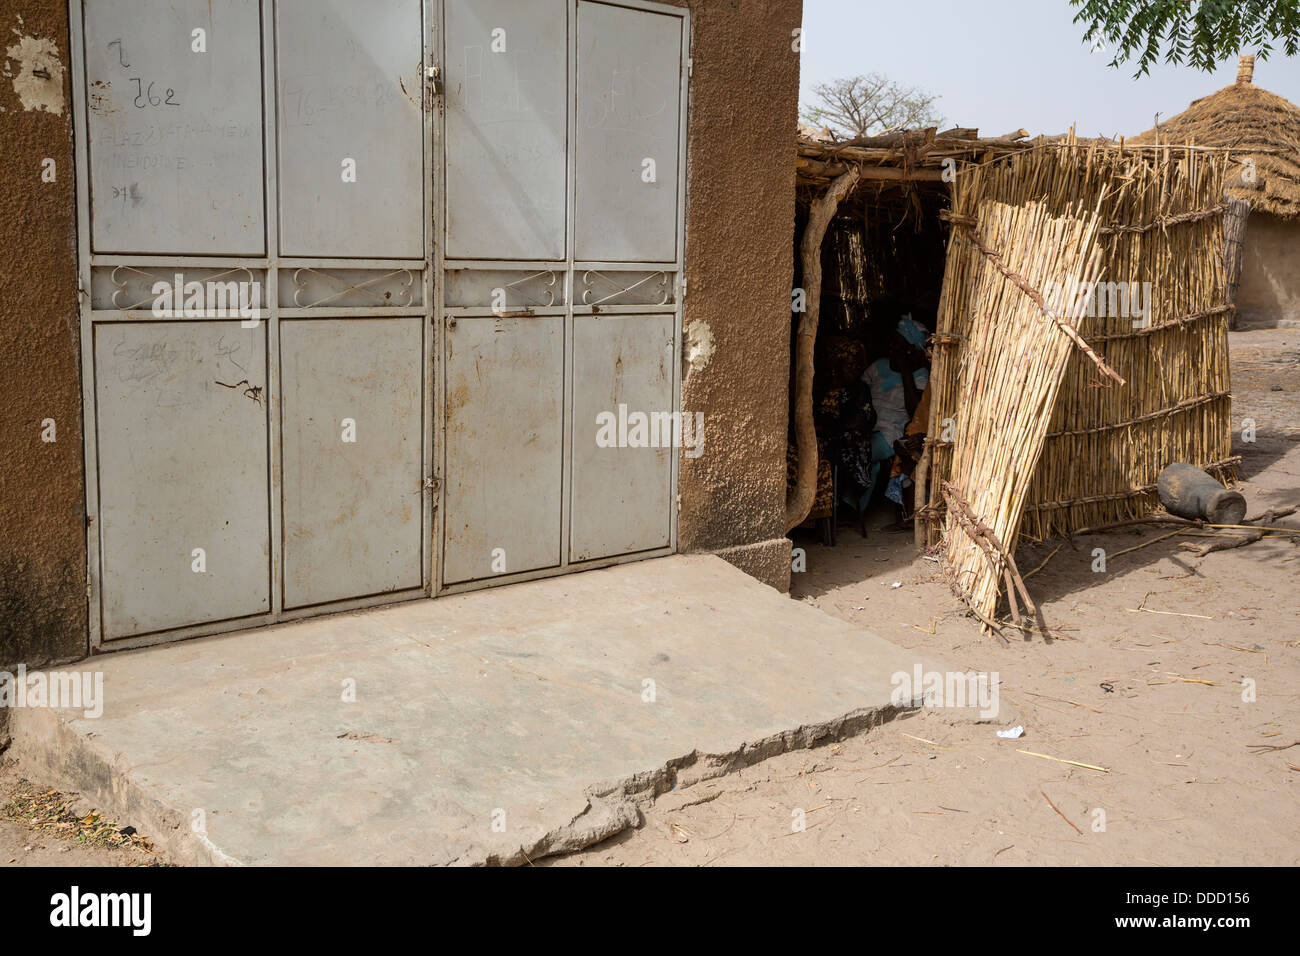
[483,705,920,866]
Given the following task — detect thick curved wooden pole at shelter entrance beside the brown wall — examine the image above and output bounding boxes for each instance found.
[785,166,858,532]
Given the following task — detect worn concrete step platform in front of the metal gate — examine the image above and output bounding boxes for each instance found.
[10,555,967,865]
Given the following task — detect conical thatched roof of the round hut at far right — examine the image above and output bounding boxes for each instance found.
[1128,56,1300,219]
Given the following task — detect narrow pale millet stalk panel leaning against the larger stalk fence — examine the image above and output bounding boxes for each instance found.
[937,202,1102,626]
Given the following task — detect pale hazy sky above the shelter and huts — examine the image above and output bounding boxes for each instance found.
[801,0,1300,137]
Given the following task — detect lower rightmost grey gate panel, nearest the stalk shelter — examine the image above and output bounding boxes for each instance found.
[569,313,676,561]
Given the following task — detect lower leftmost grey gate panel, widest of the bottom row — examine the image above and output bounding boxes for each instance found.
[95,321,270,639]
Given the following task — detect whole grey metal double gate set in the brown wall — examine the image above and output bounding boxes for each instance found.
[70,0,702,648]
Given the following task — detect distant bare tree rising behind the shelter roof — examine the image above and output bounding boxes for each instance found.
[802,73,944,139]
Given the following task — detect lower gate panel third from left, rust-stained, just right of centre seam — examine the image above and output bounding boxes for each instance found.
[443,316,564,584]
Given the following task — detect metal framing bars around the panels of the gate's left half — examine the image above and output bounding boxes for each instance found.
[68,0,442,654]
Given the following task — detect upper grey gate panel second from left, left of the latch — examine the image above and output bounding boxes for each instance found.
[276,0,425,259]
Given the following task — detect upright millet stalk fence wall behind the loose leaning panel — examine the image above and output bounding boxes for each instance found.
[927,143,1238,561]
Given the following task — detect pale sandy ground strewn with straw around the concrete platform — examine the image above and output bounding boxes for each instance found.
[0,330,1300,866]
